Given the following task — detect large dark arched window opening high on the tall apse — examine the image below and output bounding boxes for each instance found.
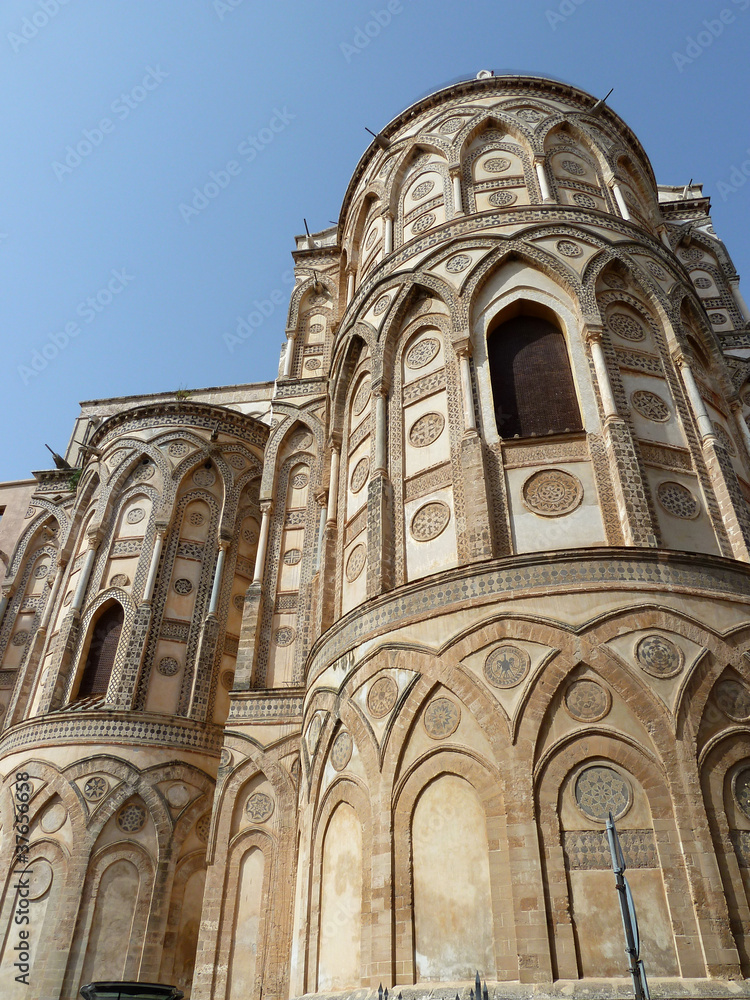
[487,316,582,438]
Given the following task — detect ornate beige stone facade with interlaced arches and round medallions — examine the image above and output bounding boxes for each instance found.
[0,77,750,1000]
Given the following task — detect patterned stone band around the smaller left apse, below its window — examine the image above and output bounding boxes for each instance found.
[0,711,224,757]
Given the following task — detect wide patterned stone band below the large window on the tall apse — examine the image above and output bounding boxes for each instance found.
[308,548,750,678]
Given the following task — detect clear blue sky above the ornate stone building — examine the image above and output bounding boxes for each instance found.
[0,0,750,480]
